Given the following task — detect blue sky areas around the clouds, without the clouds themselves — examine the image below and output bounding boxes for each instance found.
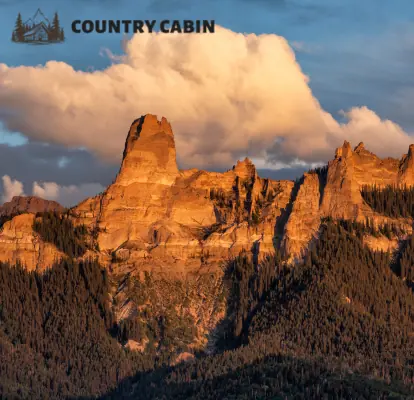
[0,0,414,205]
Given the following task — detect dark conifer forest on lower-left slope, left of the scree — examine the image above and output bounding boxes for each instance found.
[0,261,164,399]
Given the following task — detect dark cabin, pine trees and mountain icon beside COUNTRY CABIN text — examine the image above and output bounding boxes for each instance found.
[12,8,65,44]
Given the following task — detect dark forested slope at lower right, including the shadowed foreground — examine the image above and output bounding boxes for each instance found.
[102,222,414,399]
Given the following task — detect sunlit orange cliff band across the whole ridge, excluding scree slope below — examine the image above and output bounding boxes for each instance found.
[0,115,414,275]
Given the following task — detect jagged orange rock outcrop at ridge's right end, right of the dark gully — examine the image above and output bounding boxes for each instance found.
[283,141,414,258]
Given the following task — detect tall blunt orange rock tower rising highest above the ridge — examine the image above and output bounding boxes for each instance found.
[116,114,179,186]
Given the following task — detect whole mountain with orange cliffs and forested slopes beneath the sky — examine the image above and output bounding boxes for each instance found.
[0,115,414,399]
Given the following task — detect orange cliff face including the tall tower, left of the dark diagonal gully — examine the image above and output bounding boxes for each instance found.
[73,115,293,273]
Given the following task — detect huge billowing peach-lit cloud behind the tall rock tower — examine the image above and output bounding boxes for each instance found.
[0,28,411,167]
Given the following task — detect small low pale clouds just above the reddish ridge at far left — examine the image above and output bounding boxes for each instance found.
[2,175,104,207]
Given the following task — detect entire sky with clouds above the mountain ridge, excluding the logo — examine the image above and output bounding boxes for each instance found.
[0,0,414,206]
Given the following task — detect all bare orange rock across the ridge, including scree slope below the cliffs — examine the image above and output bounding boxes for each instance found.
[0,115,414,354]
